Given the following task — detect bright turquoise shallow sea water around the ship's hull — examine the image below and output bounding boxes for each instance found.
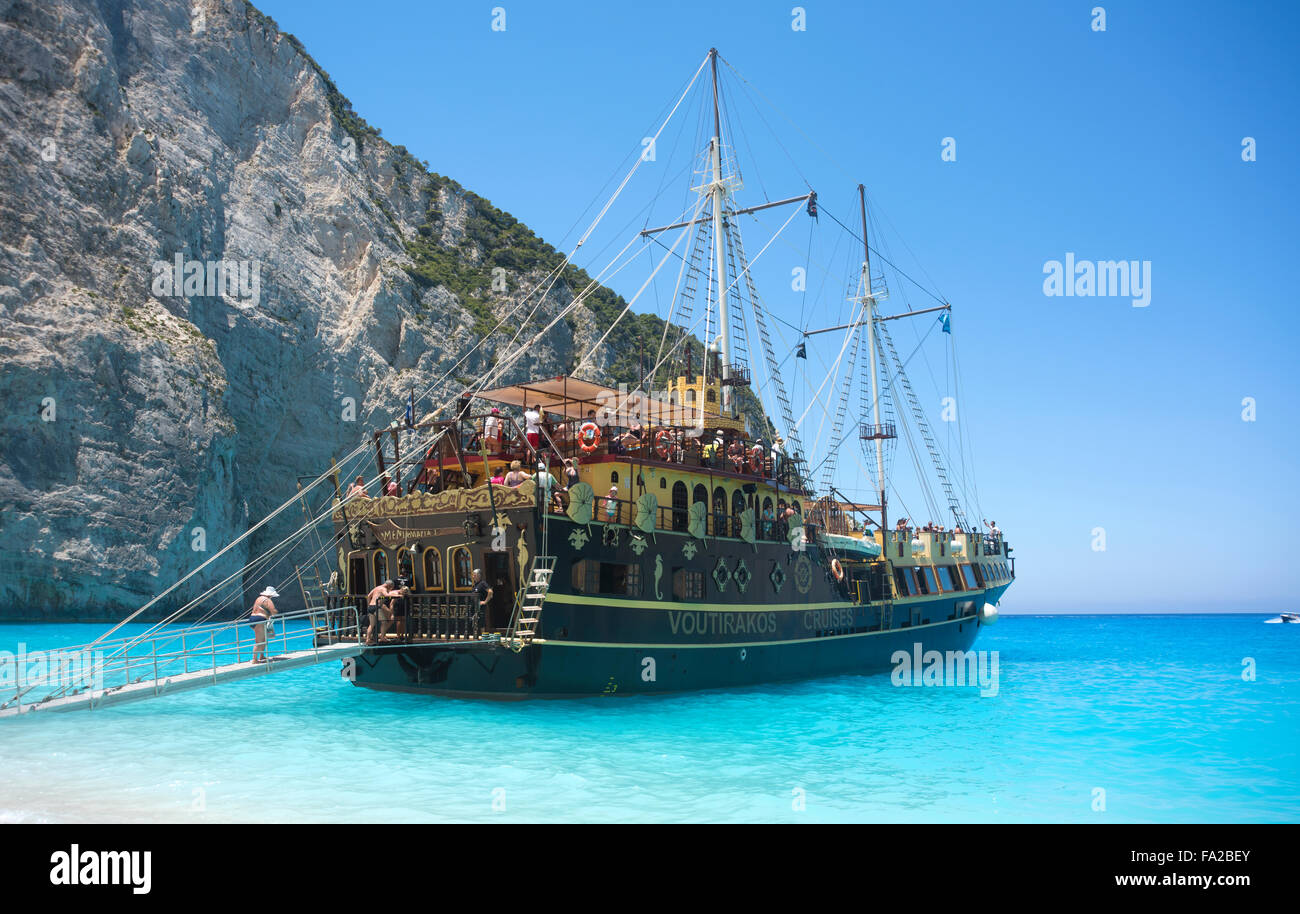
[0,615,1300,822]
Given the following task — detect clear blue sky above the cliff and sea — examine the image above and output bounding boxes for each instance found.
[250,0,1300,611]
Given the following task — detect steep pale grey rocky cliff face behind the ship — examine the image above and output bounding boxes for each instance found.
[0,0,696,619]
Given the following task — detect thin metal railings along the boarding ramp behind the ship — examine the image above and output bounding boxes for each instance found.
[0,606,359,711]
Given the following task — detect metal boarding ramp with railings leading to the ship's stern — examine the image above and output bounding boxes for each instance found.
[0,605,363,718]
